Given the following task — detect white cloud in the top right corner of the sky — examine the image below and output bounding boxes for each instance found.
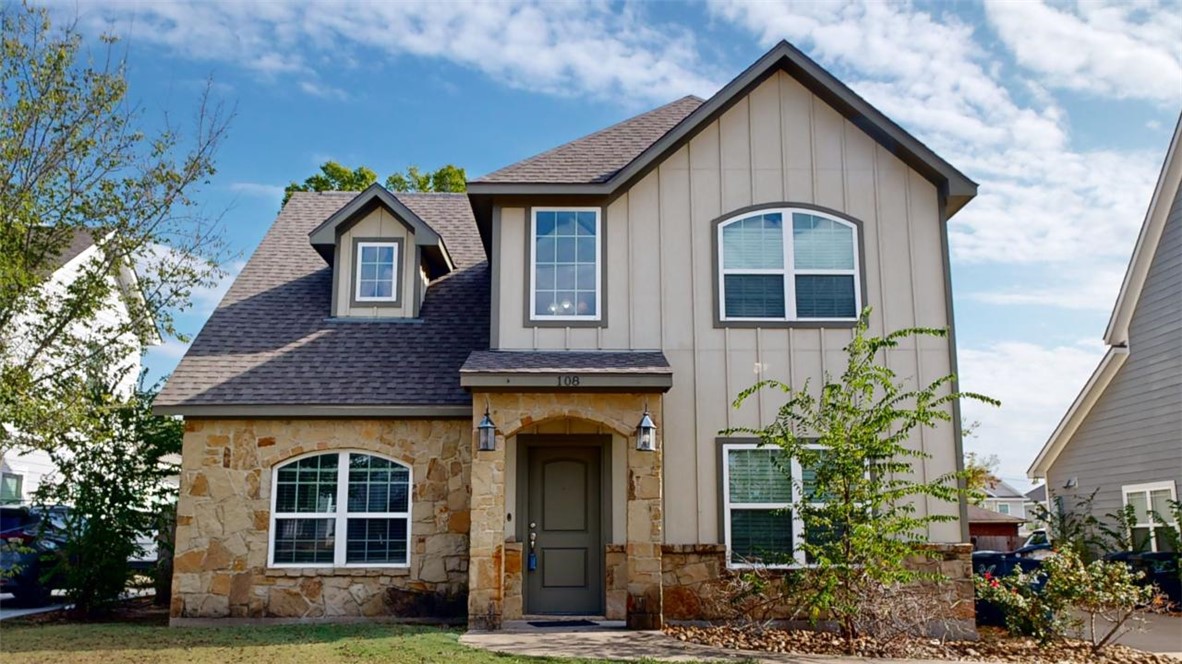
[985,0,1182,104]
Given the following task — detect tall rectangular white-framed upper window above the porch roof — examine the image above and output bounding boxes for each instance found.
[530,208,603,321]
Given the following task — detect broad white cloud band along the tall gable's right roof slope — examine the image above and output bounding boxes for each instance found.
[710,0,1164,263]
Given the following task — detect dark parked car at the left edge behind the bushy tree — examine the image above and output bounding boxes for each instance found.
[0,507,69,606]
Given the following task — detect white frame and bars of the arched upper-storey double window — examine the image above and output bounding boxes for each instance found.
[715,207,862,323]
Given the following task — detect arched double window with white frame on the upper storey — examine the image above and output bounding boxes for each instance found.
[717,208,862,321]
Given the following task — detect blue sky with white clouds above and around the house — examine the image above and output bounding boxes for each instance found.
[54,0,1182,486]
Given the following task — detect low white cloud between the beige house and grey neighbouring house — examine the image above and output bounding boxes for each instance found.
[960,341,1104,481]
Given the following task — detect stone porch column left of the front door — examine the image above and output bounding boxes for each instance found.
[468,393,505,630]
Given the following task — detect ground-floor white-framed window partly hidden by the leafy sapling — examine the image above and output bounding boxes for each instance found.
[722,443,823,567]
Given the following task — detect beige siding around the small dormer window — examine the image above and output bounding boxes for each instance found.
[333,208,426,318]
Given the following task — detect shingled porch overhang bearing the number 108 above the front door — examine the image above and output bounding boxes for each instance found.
[460,351,673,392]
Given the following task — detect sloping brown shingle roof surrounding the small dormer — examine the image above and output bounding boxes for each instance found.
[156,191,489,406]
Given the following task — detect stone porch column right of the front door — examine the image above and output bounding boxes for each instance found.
[625,397,665,630]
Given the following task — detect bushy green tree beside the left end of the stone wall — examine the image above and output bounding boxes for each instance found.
[35,385,184,616]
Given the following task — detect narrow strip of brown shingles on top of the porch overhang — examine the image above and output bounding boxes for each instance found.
[460,351,673,373]
